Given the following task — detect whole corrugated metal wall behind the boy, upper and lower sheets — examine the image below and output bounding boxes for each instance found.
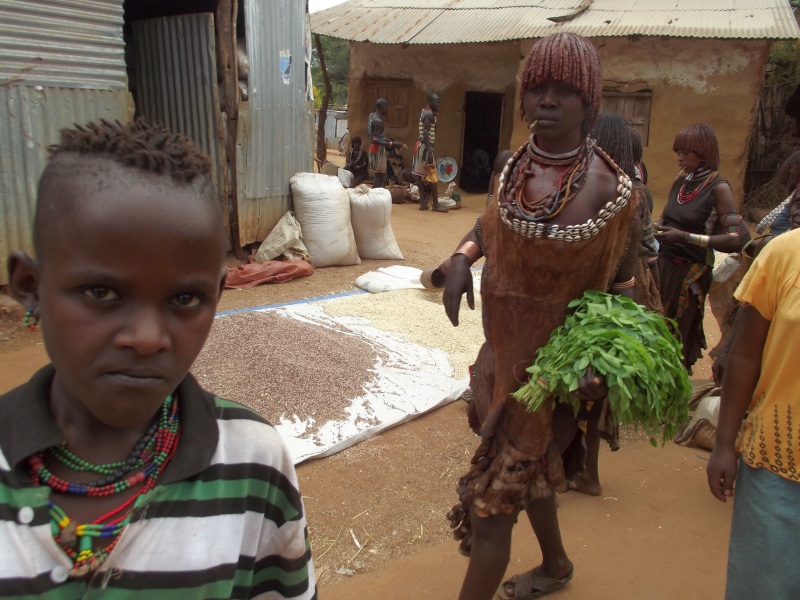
[0,0,132,285]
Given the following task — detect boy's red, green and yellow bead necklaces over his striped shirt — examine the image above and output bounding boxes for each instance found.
[28,396,180,577]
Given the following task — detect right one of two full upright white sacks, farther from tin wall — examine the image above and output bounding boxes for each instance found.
[347,185,405,260]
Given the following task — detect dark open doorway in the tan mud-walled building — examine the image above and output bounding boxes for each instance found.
[460,92,504,194]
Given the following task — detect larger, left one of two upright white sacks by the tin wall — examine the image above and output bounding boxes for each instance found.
[289,173,361,267]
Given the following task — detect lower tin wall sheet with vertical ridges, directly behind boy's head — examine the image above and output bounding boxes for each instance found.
[0,85,133,285]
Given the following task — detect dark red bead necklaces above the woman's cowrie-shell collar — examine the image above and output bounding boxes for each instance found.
[500,136,594,222]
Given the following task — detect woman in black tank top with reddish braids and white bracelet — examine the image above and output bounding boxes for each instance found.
[655,123,746,375]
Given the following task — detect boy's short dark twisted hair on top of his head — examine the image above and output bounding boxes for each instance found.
[49,117,211,183]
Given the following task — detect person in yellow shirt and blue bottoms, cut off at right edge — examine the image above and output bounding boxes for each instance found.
[707,190,800,600]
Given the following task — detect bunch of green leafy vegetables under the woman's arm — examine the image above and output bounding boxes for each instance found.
[513,290,692,446]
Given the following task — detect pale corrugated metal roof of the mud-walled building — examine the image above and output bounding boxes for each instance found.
[311,0,800,44]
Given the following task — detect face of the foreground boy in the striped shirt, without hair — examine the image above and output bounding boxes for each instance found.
[27,161,225,428]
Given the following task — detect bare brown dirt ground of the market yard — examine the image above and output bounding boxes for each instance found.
[0,157,731,600]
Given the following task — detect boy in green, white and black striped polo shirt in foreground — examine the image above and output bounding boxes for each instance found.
[0,120,316,600]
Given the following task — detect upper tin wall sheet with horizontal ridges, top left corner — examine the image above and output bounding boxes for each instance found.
[0,0,128,90]
